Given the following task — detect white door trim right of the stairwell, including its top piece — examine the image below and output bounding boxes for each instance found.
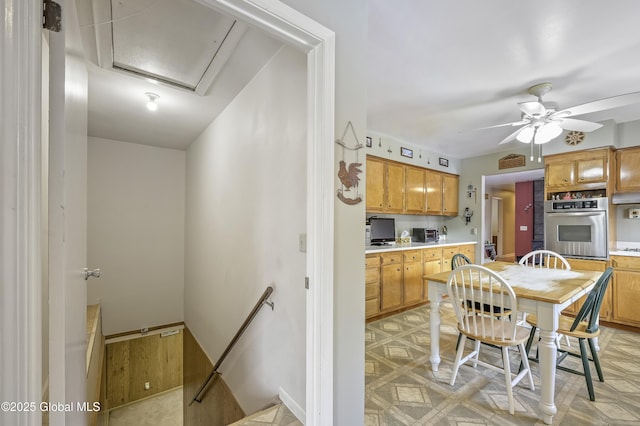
[190,0,335,425]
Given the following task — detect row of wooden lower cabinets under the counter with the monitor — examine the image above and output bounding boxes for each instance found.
[365,244,475,319]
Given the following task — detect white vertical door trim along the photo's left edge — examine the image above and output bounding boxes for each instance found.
[0,0,42,425]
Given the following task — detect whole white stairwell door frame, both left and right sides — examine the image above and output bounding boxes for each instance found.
[0,0,335,425]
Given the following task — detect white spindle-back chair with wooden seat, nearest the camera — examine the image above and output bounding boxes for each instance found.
[447,264,534,414]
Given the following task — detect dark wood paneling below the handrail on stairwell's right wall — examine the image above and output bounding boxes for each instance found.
[183,327,245,426]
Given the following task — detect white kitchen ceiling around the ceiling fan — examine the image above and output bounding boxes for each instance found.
[367,0,640,158]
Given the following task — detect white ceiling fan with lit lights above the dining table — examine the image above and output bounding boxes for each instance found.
[483,83,640,162]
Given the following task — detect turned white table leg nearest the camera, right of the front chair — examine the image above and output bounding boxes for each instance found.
[538,329,558,425]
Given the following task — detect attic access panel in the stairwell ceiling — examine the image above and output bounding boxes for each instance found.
[111,0,237,91]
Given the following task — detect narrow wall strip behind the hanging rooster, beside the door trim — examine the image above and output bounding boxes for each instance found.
[284,0,368,425]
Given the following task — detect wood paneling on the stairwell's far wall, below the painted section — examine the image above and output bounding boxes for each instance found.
[106,330,183,408]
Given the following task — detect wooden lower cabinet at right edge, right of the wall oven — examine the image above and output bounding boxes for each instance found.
[611,256,640,327]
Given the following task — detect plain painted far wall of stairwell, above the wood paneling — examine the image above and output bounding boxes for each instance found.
[87,138,185,335]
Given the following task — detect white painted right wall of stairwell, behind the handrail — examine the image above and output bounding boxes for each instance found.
[184,47,307,413]
